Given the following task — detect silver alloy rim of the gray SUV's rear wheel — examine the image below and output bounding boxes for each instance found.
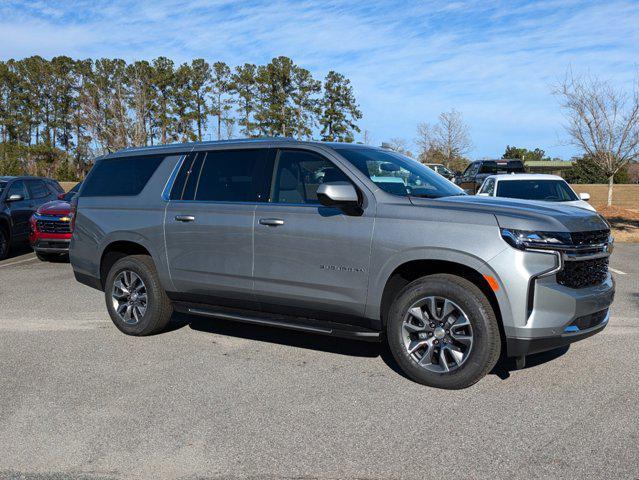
[111,270,148,325]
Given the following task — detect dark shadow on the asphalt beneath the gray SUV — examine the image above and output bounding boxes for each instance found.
[165,312,569,380]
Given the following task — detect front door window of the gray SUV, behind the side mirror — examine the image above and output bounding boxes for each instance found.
[270,150,350,205]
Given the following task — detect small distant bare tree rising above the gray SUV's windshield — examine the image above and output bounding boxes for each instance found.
[415,109,473,167]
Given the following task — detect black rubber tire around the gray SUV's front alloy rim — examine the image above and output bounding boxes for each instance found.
[386,274,501,389]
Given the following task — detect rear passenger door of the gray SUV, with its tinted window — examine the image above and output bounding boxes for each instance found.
[165,149,269,306]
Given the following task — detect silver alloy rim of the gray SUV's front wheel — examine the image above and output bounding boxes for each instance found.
[402,296,473,373]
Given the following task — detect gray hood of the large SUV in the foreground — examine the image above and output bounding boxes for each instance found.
[410,195,610,232]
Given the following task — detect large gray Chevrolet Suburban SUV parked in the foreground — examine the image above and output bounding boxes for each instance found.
[70,139,614,388]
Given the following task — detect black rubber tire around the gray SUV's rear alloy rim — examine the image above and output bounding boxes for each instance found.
[104,255,173,336]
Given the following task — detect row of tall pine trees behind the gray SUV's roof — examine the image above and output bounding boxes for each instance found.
[0,56,362,179]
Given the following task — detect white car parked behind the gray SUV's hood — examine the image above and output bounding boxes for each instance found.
[477,173,595,212]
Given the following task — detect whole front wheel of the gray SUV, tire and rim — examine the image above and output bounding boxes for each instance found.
[387,274,501,389]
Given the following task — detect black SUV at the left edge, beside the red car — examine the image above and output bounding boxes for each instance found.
[0,176,64,260]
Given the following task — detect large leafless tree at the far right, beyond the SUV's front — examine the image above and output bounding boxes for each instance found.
[555,73,639,206]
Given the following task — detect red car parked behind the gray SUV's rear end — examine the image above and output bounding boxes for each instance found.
[29,183,80,261]
